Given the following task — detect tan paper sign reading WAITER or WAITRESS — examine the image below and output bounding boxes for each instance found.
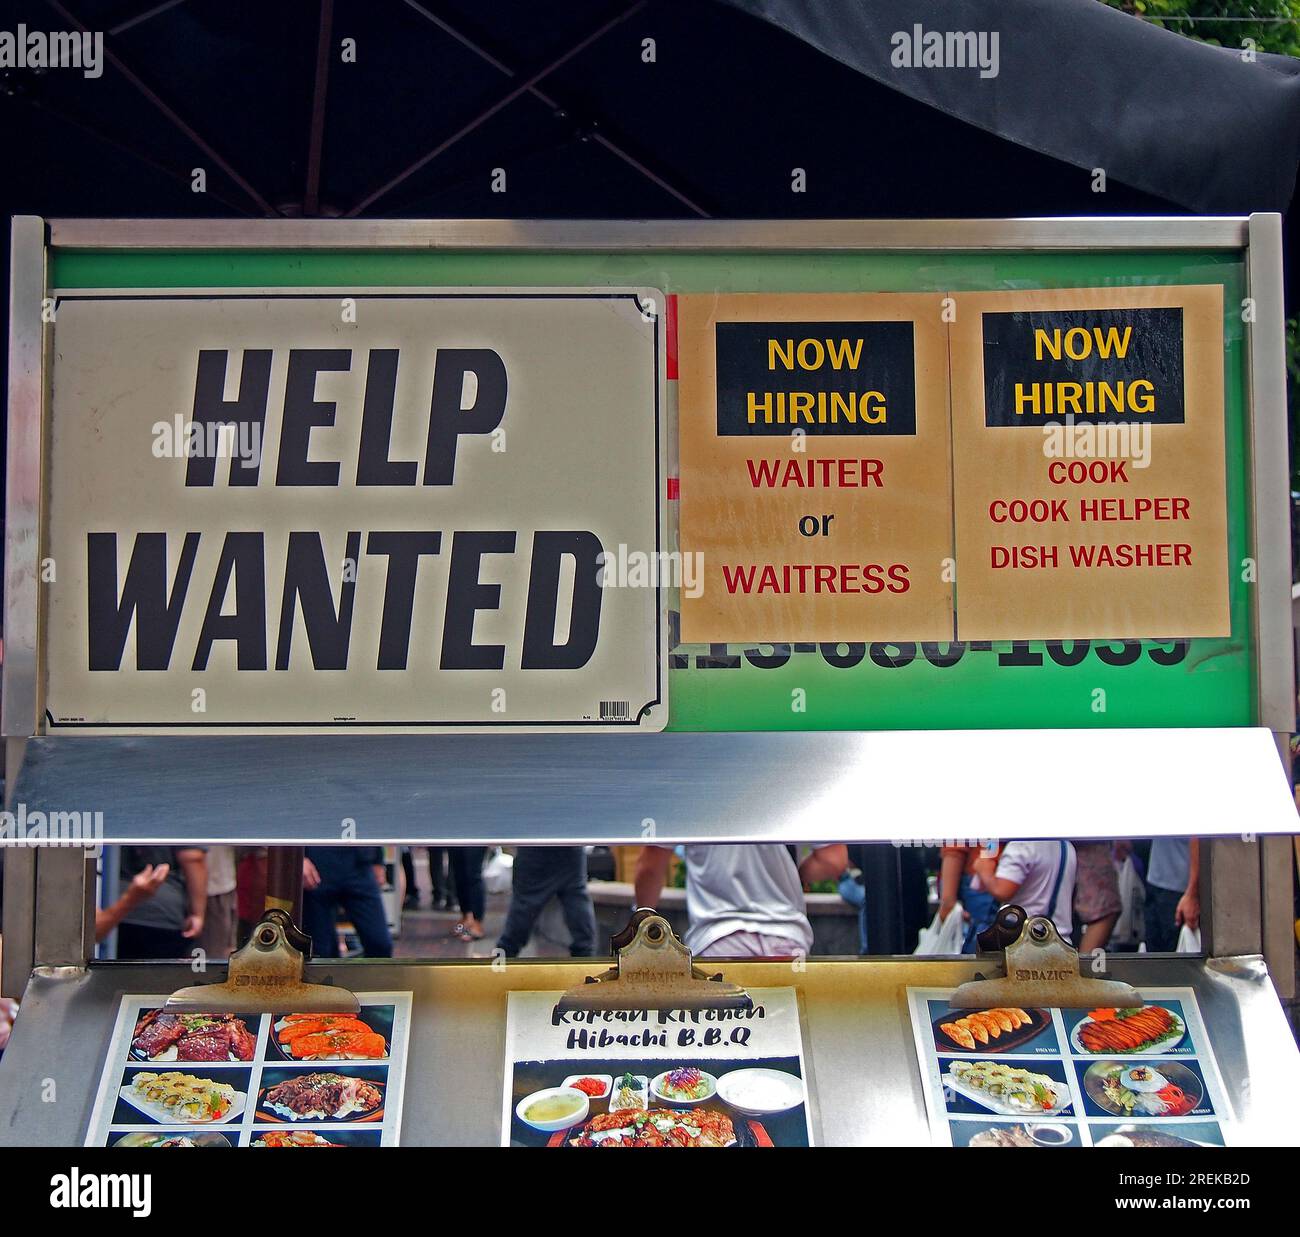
[677,294,953,643]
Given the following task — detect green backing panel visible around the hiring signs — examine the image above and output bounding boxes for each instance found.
[51,251,1256,732]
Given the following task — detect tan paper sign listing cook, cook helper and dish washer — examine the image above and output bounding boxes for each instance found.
[952,285,1230,641]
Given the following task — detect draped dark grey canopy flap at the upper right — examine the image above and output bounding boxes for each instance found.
[722,0,1300,214]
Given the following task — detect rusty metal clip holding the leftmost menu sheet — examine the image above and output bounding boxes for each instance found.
[164,908,361,1014]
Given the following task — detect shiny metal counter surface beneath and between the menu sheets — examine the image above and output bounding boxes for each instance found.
[0,955,1300,1146]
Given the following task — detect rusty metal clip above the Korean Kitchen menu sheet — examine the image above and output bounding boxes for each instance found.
[556,907,754,1012]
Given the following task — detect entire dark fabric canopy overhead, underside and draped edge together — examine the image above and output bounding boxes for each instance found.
[0,0,1300,506]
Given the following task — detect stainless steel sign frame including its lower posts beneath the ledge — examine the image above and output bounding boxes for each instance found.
[0,213,1295,989]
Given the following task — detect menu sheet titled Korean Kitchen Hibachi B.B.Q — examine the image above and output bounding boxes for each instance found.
[501,988,813,1147]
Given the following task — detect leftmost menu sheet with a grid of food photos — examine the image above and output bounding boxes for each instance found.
[86,993,411,1147]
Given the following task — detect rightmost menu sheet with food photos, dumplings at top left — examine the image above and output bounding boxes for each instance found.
[907,988,1232,1147]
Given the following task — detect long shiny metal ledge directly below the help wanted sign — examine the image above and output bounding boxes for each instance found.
[4,728,1297,845]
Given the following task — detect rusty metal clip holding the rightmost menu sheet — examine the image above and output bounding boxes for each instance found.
[948,906,1143,1010]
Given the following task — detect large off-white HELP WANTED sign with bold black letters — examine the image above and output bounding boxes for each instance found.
[44,288,668,733]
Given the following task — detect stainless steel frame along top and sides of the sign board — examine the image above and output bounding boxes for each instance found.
[0,214,1295,973]
